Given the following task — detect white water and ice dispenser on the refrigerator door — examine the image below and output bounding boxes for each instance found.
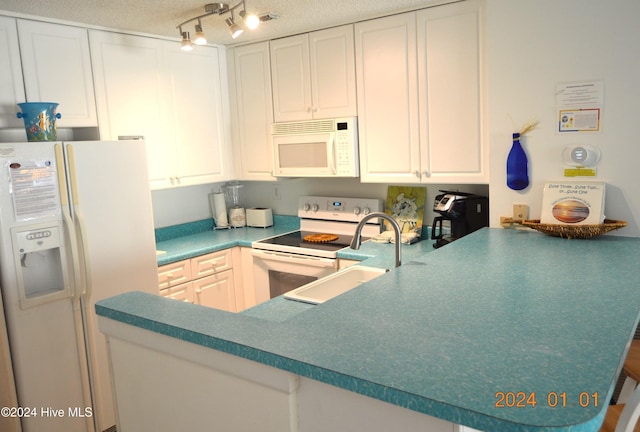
[13,225,70,309]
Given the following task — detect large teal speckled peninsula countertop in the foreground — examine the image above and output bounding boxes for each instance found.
[96,228,640,431]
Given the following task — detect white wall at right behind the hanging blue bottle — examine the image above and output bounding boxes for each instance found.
[487,0,640,237]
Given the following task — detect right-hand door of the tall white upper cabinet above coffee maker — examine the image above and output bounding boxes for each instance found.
[418,1,488,183]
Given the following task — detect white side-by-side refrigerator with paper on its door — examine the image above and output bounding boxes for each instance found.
[0,141,158,432]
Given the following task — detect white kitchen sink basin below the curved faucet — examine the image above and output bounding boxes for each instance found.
[284,265,387,304]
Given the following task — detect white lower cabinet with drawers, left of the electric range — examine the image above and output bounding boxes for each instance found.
[158,247,244,312]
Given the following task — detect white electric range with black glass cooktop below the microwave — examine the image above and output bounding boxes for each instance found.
[251,196,382,303]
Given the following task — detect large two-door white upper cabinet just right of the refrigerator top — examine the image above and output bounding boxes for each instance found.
[90,30,228,189]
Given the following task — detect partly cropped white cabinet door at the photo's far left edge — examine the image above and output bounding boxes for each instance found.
[0,17,26,128]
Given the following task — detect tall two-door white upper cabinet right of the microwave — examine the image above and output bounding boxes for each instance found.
[355,0,489,183]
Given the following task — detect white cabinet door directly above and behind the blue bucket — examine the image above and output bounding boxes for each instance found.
[18,20,98,127]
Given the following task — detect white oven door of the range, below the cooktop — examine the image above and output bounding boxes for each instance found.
[251,249,338,304]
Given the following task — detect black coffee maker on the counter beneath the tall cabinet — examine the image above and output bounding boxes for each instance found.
[431,190,489,248]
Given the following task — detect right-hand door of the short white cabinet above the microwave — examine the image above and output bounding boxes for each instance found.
[309,25,358,118]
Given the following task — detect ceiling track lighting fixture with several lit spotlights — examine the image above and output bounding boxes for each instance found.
[176,0,280,50]
